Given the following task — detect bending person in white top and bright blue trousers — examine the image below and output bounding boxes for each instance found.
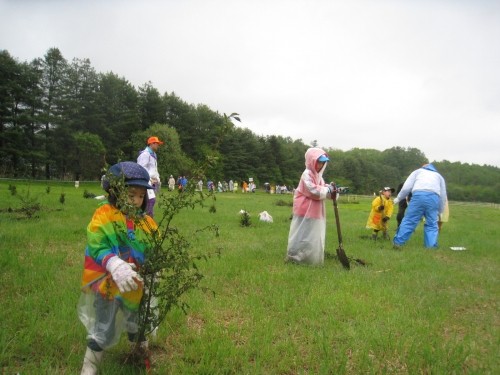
[392,164,448,249]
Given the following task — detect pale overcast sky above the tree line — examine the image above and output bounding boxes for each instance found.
[0,0,500,167]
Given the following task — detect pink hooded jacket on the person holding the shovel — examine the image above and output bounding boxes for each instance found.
[293,147,329,219]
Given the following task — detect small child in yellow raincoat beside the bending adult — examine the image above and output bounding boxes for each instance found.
[366,186,394,240]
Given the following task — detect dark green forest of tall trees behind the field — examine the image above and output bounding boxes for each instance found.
[0,48,500,203]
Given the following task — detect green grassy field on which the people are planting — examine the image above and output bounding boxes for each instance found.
[0,180,500,374]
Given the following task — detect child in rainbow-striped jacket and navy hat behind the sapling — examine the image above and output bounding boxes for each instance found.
[78,161,157,375]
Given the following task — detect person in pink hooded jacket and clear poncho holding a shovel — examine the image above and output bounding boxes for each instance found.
[286,147,337,265]
